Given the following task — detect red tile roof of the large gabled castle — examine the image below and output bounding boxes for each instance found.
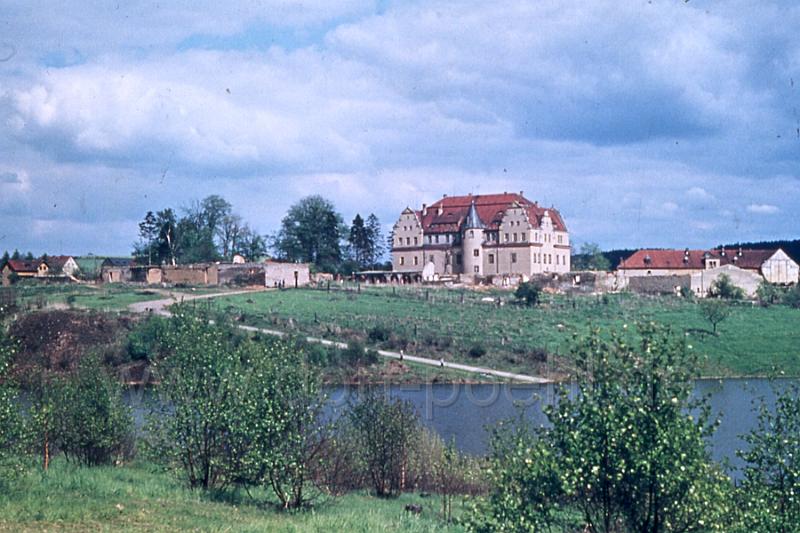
[416,193,567,233]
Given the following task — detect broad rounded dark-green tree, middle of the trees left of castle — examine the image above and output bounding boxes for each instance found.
[274,196,346,270]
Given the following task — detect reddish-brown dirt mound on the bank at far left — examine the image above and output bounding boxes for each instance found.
[10,310,133,372]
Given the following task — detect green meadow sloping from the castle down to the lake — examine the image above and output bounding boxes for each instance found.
[215,287,800,376]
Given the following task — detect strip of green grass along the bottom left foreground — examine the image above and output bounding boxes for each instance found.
[0,460,462,533]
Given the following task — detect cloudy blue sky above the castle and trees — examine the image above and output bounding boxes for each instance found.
[0,0,800,255]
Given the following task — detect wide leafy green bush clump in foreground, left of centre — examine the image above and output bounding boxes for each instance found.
[149,306,325,508]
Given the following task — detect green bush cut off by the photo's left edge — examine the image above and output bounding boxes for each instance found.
[0,332,25,486]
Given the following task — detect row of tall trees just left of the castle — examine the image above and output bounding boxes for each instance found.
[133,195,387,274]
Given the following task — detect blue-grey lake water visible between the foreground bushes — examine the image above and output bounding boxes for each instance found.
[126,379,791,476]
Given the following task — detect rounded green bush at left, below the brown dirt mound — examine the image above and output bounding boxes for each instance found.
[52,356,133,466]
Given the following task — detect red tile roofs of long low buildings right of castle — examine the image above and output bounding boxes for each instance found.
[619,249,778,270]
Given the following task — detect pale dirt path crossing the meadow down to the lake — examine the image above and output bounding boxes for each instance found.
[128,289,551,384]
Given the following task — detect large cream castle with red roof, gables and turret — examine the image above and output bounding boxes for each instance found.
[392,192,570,280]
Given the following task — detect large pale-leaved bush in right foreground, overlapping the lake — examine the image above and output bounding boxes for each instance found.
[468,324,732,533]
